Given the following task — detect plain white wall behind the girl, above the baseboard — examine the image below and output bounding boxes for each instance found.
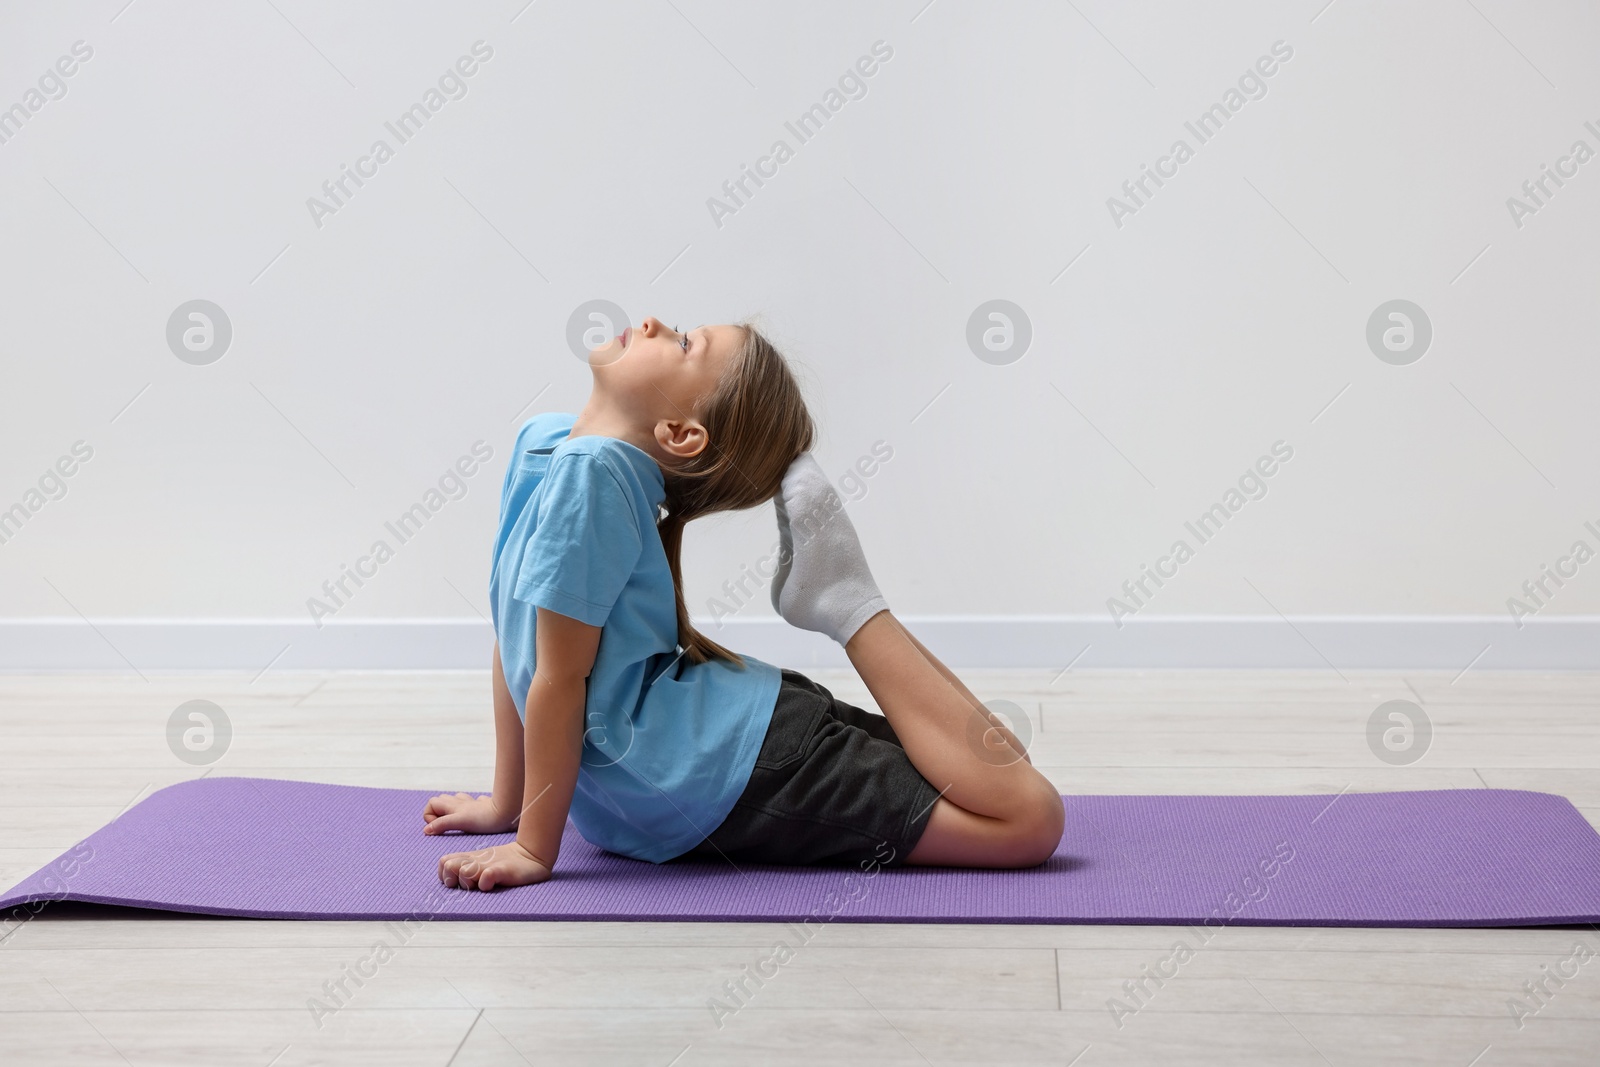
[0,0,1600,662]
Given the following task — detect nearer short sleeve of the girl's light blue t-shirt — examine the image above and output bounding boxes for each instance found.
[515,453,643,625]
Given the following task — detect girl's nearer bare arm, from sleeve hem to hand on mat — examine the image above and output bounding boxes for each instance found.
[438,608,600,889]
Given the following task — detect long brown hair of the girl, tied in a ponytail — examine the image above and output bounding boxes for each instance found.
[656,322,816,667]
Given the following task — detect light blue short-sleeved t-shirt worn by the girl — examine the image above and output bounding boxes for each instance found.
[490,413,781,862]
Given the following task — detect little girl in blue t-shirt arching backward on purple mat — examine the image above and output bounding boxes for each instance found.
[422,318,1064,889]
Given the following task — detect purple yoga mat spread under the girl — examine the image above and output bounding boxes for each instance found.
[0,777,1600,936]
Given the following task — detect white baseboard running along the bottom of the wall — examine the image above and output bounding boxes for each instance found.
[0,616,1600,672]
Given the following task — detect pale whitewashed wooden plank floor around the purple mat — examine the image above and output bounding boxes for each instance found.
[0,670,1600,1067]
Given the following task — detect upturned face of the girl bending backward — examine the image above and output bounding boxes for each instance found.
[589,317,744,426]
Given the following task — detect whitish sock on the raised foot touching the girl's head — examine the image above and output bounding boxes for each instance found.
[773,453,890,645]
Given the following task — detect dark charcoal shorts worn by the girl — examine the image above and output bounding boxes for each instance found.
[686,670,939,867]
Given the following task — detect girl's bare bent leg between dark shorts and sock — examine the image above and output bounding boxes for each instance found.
[845,611,1066,867]
